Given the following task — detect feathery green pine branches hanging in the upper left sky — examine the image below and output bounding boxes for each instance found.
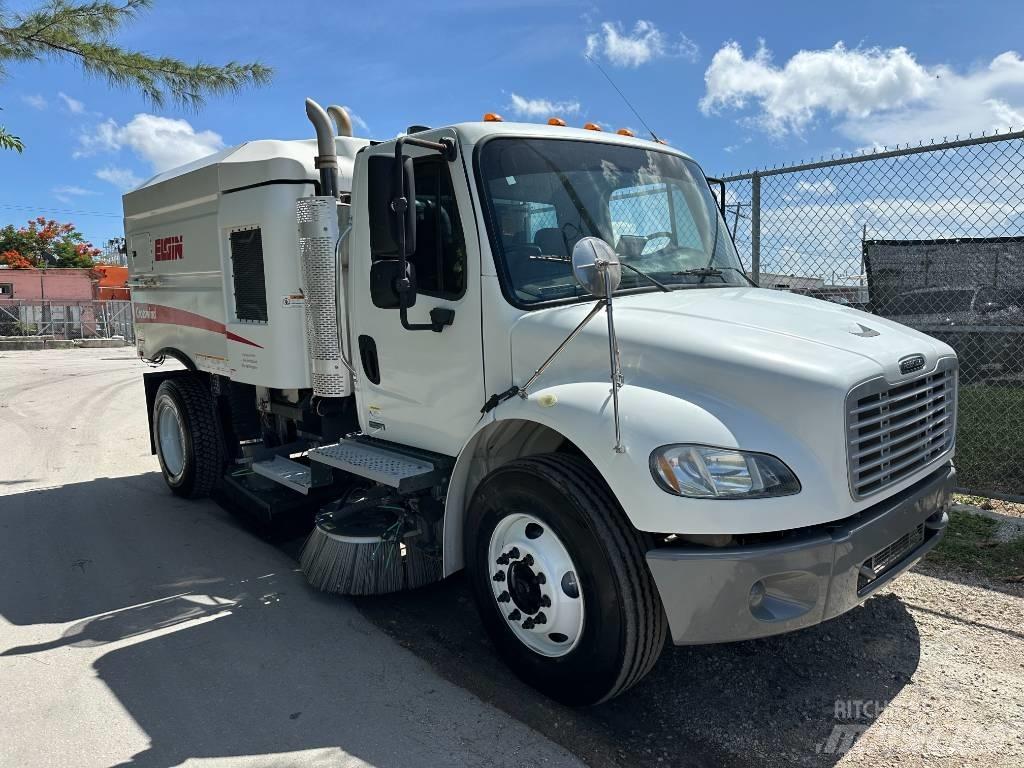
[0,0,271,152]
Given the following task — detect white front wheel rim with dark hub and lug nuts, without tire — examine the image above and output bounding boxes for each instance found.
[487,513,584,657]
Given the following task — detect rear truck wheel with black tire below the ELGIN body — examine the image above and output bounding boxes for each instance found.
[153,375,224,499]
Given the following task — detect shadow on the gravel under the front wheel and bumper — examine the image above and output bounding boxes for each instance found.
[356,561,921,766]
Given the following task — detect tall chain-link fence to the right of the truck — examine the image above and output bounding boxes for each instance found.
[724,132,1024,497]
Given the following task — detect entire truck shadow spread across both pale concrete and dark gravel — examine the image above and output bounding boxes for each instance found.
[0,473,920,768]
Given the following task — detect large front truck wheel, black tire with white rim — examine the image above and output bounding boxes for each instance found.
[464,454,667,706]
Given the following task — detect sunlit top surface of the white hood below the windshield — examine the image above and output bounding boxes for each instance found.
[512,288,953,399]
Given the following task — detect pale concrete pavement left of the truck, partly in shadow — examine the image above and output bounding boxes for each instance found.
[0,349,581,768]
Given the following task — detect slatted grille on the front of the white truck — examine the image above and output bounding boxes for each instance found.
[846,357,956,499]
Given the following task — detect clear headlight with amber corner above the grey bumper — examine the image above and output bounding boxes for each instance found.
[650,444,800,499]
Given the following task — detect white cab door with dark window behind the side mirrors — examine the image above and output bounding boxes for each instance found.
[348,129,485,456]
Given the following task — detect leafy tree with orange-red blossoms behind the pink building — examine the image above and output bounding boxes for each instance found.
[0,216,100,269]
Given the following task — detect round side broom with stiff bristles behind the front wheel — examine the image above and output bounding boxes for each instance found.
[299,518,442,595]
